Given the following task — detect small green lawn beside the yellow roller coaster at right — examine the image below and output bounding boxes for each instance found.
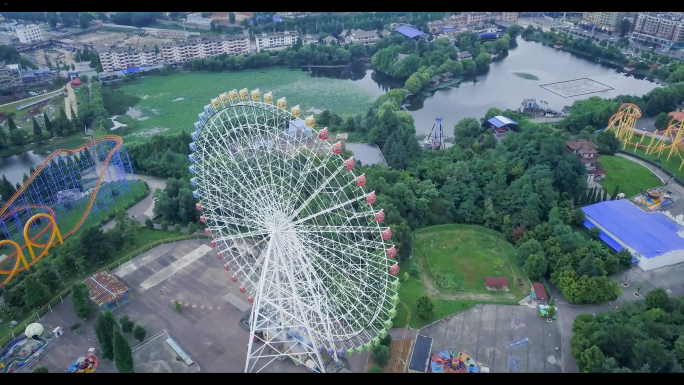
[599,155,663,197]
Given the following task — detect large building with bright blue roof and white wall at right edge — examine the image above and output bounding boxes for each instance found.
[582,199,684,270]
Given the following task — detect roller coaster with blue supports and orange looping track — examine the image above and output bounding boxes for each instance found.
[0,136,134,287]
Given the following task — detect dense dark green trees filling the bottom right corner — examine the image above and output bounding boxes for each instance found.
[571,289,684,373]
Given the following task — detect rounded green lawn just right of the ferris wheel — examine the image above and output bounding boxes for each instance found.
[413,225,529,299]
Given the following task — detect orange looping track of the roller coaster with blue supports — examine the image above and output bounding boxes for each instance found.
[0,135,123,287]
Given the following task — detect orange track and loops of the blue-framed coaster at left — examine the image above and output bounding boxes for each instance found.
[0,135,123,287]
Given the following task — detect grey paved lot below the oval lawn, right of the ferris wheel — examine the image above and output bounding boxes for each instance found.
[418,305,563,373]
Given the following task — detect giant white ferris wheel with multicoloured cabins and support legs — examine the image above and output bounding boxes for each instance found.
[189,88,399,372]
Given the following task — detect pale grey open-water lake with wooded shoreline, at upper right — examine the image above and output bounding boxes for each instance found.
[311,38,658,136]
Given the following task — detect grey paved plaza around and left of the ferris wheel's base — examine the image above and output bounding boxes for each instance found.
[31,240,368,373]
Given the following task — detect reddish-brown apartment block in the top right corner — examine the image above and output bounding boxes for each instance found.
[632,12,684,47]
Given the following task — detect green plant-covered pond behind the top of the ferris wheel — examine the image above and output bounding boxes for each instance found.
[115,68,374,143]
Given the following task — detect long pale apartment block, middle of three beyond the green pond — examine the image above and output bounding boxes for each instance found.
[160,35,249,64]
